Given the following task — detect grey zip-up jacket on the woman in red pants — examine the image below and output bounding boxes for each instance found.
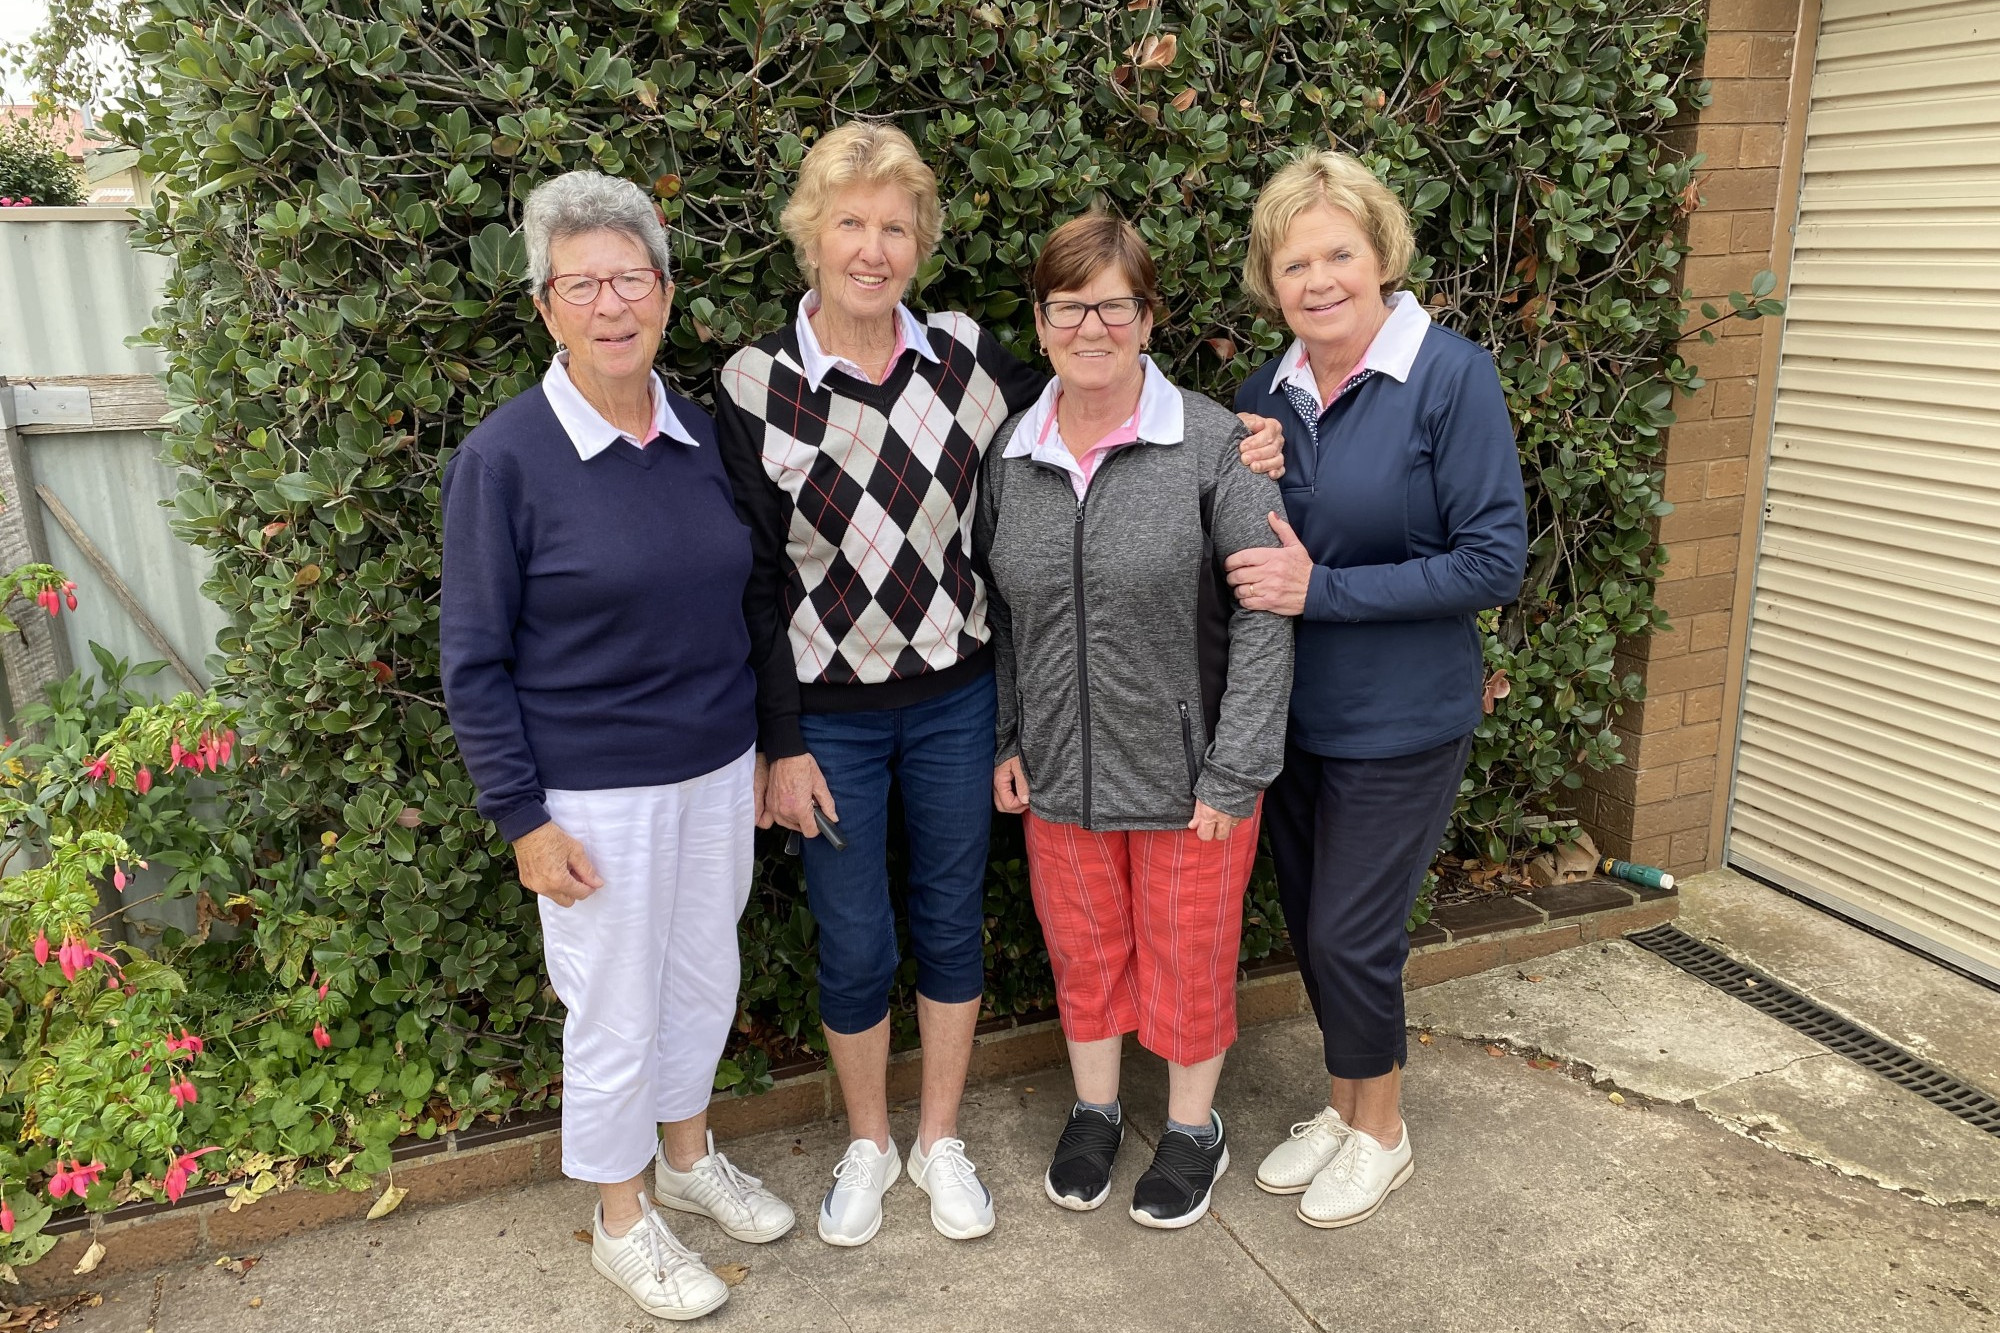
[974,362,1292,831]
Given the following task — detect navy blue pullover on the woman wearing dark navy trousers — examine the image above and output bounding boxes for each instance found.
[1236,324,1528,759]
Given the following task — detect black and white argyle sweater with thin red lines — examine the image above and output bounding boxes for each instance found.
[716,312,1046,759]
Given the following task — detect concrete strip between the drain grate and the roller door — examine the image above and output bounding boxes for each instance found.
[1678,871,2000,1097]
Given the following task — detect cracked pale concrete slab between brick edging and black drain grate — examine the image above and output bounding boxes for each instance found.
[1408,928,1826,1103]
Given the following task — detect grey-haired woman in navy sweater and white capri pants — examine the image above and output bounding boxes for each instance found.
[442,172,794,1319]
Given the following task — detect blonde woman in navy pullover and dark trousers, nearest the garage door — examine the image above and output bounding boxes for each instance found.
[1228,152,1528,1227]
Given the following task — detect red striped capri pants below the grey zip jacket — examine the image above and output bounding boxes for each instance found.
[1022,803,1262,1065]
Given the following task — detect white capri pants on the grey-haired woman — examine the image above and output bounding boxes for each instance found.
[542,749,756,1185]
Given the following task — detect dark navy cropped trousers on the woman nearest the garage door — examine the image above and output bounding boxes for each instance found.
[1264,735,1472,1079]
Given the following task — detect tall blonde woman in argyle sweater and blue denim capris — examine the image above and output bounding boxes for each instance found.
[716,122,1278,1245]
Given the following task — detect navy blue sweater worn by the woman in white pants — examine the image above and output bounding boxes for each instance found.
[440,384,756,841]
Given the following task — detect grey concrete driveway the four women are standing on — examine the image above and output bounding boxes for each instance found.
[64,872,2000,1333]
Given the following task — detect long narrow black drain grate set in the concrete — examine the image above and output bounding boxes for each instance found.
[1626,925,2000,1137]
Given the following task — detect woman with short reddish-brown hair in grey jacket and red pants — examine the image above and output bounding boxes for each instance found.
[974,214,1292,1229]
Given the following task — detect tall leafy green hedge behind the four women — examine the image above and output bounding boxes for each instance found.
[0,0,1704,1232]
